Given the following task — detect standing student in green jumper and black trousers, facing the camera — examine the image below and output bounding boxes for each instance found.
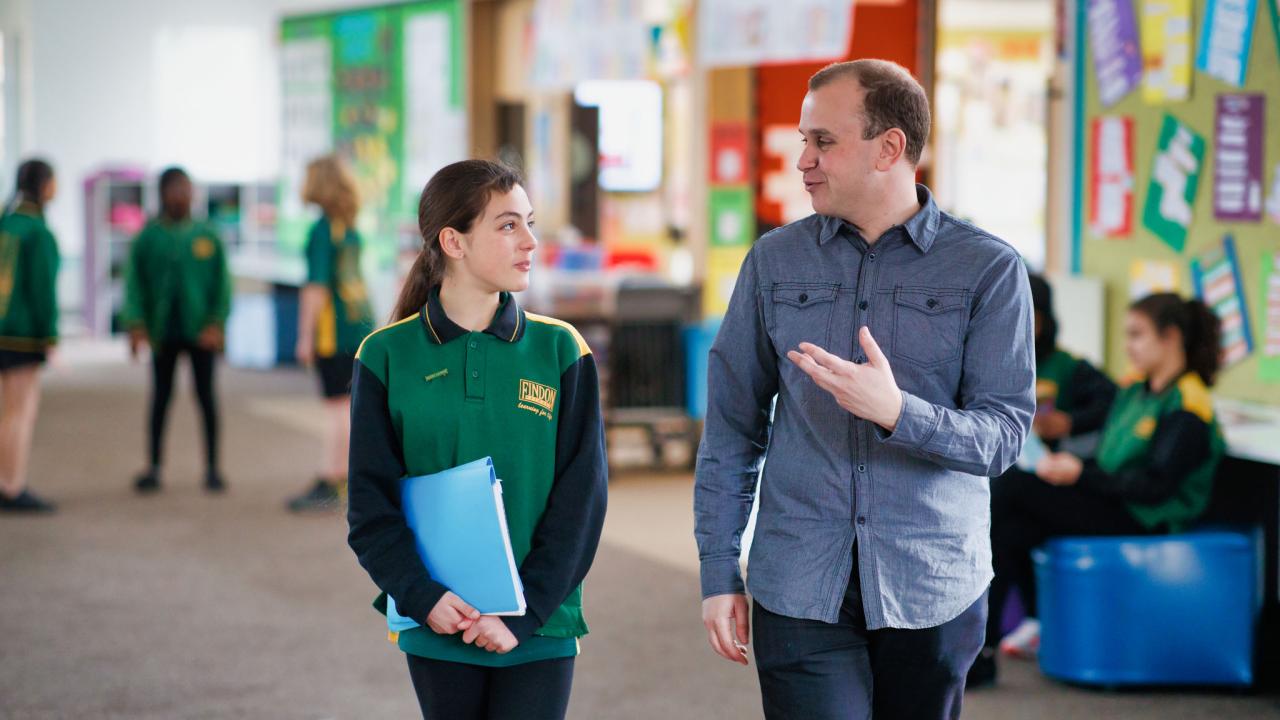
[122,168,232,493]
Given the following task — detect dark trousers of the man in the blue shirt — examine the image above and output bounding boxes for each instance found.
[751,545,987,720]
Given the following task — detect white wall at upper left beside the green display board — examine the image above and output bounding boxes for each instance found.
[0,0,381,305]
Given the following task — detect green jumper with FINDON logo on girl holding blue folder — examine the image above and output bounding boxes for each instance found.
[348,283,608,666]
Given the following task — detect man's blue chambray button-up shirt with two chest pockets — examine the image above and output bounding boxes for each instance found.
[694,186,1036,630]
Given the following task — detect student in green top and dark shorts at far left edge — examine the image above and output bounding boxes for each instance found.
[0,160,59,512]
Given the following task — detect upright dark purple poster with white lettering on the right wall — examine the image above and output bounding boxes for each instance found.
[1213,95,1266,223]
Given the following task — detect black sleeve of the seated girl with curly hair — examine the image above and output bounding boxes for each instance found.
[1079,410,1211,505]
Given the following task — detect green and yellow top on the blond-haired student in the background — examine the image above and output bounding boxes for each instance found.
[306,218,374,357]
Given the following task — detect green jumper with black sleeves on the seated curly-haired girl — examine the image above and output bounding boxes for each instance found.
[1082,373,1226,533]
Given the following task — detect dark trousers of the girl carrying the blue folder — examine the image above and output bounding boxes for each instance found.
[406,653,573,720]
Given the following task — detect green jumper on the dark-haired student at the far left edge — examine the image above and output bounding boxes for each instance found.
[0,202,59,352]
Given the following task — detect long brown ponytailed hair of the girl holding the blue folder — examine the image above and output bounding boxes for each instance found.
[390,160,521,323]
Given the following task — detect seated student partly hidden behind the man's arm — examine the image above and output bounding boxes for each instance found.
[986,274,1116,659]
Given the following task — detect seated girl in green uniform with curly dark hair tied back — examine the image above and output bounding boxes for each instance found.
[969,293,1225,685]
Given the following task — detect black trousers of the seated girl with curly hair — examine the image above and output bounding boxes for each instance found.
[986,468,1151,647]
